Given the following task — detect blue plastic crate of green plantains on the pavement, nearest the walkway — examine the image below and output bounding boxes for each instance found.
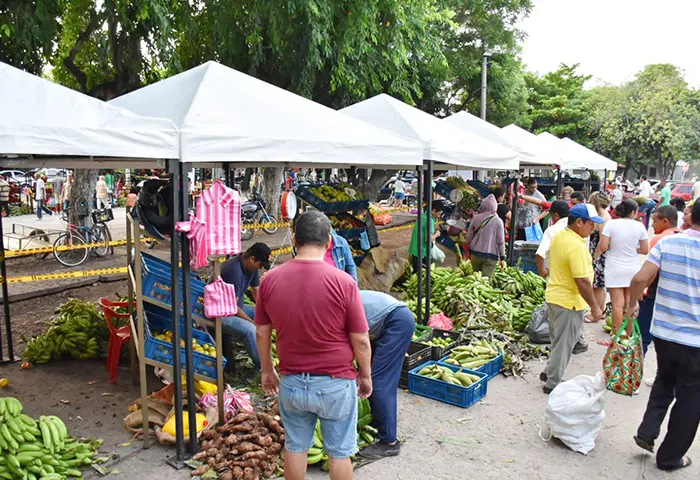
[408,362,488,408]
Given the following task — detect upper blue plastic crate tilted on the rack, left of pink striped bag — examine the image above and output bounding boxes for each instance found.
[141,255,206,318]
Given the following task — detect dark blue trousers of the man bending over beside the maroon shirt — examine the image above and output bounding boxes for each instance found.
[369,307,415,443]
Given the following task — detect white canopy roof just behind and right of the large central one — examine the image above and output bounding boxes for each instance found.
[340,94,518,170]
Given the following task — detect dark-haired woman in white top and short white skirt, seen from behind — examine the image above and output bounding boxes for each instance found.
[595,200,649,332]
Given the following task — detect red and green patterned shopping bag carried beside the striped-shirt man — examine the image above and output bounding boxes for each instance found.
[603,318,644,396]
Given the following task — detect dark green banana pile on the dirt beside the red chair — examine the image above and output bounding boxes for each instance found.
[22,298,109,363]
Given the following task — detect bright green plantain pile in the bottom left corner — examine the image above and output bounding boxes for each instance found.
[0,397,101,480]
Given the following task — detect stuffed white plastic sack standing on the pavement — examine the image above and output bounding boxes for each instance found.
[545,372,605,455]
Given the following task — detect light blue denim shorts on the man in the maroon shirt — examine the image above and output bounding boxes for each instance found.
[279,373,357,458]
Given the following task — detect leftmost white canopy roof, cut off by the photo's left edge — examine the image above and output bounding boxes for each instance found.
[0,62,178,159]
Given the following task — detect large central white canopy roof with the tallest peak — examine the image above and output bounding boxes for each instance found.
[111,62,422,166]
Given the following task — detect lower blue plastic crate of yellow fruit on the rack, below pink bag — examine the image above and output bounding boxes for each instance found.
[144,305,226,379]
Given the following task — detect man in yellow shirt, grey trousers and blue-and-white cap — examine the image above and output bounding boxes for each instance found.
[540,204,604,393]
